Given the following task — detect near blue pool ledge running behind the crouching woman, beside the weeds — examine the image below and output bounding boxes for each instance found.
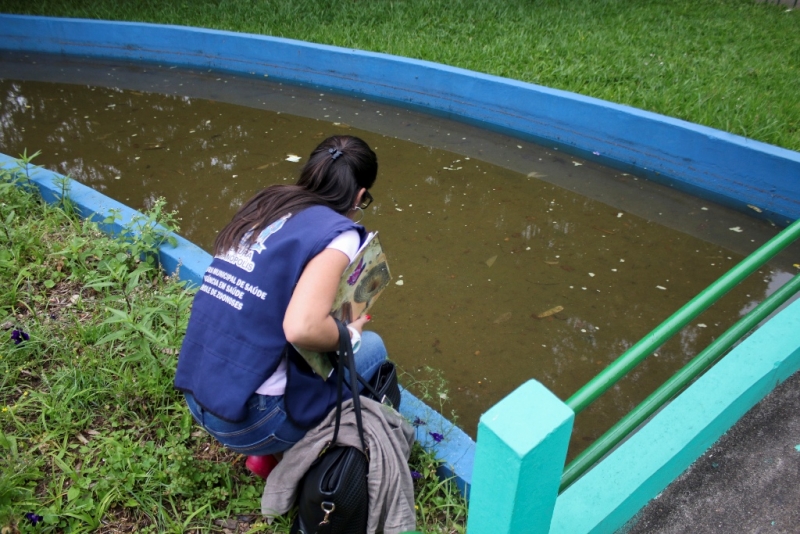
[0,153,475,495]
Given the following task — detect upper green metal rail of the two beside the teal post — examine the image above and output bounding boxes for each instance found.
[566,219,800,414]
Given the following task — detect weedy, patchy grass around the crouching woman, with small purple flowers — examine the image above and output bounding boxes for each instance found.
[0,160,466,533]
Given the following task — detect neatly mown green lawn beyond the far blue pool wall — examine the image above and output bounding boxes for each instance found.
[0,0,800,150]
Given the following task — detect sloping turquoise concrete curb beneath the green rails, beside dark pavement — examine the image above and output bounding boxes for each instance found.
[550,301,800,534]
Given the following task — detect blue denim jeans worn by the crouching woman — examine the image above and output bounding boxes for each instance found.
[184,332,386,456]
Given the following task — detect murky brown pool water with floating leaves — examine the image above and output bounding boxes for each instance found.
[0,54,791,456]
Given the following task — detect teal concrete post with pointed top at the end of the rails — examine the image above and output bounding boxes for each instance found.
[467,380,575,534]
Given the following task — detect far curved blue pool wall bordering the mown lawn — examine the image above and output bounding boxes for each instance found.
[0,15,800,226]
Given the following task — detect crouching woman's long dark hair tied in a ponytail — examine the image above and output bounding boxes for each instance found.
[214,135,378,255]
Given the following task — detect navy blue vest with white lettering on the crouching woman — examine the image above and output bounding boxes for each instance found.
[174,206,364,428]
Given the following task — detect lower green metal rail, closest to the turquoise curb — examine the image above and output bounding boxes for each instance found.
[559,274,800,491]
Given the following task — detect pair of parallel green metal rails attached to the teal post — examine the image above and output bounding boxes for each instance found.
[560,219,800,491]
